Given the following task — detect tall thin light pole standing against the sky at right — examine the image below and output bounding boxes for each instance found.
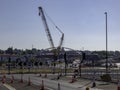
[105,12,108,73]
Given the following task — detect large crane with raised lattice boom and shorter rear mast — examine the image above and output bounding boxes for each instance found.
[38,7,64,57]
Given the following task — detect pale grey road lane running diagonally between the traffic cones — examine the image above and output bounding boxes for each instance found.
[3,74,102,90]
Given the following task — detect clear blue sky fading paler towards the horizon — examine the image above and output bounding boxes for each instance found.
[0,0,120,50]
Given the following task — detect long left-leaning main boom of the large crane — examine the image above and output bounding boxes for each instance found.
[38,7,54,49]
